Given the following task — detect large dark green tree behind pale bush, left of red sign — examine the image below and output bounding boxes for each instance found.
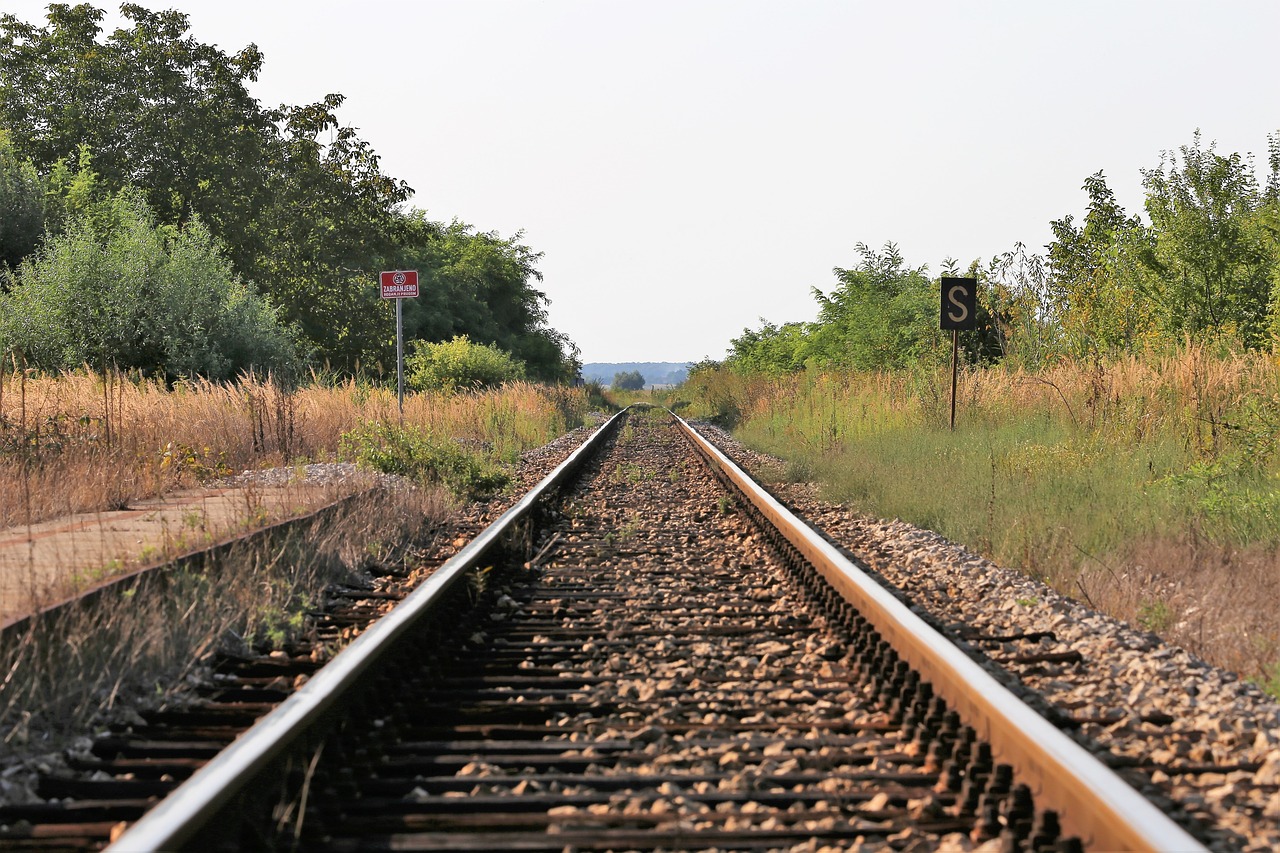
[0,4,410,369]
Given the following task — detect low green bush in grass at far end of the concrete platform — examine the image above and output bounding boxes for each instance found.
[338,423,511,500]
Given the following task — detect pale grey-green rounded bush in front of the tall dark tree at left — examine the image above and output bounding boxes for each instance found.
[0,192,297,379]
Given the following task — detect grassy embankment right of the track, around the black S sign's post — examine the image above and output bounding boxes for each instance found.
[685,350,1280,693]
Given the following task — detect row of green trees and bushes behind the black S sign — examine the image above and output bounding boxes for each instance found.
[711,132,1280,374]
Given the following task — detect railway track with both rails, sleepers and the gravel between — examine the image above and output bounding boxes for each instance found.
[0,404,1218,850]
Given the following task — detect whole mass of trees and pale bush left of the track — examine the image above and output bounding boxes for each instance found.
[0,4,579,380]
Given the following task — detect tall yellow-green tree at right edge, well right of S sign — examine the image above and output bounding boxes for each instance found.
[1048,132,1280,356]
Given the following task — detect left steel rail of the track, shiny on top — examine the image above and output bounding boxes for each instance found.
[108,410,626,852]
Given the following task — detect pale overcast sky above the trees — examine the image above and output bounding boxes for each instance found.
[0,0,1280,361]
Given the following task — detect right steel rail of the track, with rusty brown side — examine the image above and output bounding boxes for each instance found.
[676,416,1206,852]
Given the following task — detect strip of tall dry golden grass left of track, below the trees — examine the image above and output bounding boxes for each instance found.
[0,365,589,528]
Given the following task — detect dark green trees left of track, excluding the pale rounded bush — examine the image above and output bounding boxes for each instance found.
[0,4,579,380]
